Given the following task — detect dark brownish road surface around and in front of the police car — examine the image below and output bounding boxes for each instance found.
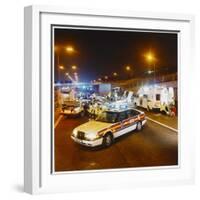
[54,117,178,172]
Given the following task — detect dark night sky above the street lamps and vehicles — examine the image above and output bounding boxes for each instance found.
[54,28,177,82]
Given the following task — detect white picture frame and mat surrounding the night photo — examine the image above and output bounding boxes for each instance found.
[24,6,195,194]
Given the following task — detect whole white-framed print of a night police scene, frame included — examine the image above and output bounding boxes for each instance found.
[24,6,194,193]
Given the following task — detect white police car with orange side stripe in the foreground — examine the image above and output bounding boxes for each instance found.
[71,109,146,147]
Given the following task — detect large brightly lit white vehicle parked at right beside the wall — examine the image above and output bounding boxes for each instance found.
[134,85,175,114]
